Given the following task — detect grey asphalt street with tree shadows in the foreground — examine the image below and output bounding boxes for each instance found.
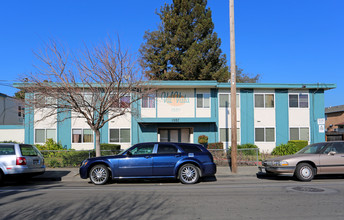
[0,175,344,219]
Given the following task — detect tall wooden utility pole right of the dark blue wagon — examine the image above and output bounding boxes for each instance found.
[229,0,237,173]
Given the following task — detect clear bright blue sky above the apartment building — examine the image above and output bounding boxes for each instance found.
[0,0,344,106]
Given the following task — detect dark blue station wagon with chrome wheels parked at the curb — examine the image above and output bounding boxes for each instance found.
[80,142,216,185]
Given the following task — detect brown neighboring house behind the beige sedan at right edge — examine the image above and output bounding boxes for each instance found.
[325,105,344,141]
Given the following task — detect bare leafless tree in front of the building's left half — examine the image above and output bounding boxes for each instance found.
[20,38,154,156]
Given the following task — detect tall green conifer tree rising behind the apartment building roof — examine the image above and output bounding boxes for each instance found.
[140,0,258,82]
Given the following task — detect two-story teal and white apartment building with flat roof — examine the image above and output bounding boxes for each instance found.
[16,81,336,152]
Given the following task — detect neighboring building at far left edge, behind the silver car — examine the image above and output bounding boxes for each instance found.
[0,93,25,143]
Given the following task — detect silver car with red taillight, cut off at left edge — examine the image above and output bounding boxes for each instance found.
[0,143,45,182]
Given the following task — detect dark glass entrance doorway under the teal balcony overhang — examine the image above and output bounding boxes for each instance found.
[158,128,193,143]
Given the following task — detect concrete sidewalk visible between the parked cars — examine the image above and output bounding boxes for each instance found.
[34,166,258,182]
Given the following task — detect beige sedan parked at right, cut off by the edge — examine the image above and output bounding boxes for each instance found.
[263,141,344,181]
